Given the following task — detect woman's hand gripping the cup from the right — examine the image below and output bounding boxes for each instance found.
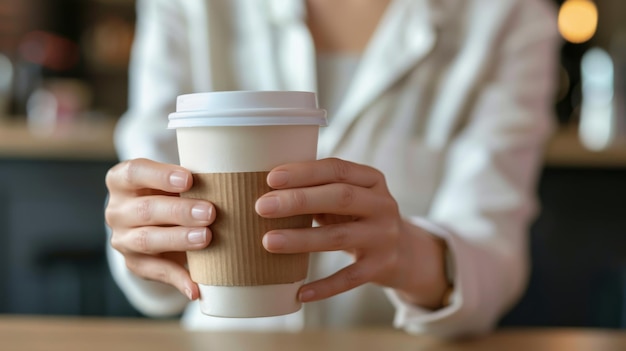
[256,159,448,308]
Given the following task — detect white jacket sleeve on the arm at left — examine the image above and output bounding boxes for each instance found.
[107,0,190,317]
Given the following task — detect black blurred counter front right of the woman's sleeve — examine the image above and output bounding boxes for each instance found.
[502,167,626,328]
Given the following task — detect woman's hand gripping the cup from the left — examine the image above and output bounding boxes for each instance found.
[105,159,215,300]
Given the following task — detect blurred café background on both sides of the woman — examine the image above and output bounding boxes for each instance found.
[0,0,626,328]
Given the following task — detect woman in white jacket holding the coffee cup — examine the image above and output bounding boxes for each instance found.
[106,0,558,337]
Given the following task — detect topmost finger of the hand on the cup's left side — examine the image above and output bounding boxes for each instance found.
[106,159,193,193]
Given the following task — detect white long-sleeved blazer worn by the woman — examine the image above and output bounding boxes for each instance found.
[109,0,558,337]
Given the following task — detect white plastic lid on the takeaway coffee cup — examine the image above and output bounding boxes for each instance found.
[168,91,328,129]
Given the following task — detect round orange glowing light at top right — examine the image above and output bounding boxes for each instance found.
[558,0,598,44]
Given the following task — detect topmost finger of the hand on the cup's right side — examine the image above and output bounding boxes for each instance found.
[267,158,384,189]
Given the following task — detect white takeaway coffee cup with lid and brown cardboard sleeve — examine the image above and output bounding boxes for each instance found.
[168,91,327,317]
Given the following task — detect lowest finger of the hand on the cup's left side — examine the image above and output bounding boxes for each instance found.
[126,255,200,300]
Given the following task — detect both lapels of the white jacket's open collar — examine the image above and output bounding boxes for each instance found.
[267,0,442,156]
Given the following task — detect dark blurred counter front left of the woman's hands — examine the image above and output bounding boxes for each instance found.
[0,159,138,316]
